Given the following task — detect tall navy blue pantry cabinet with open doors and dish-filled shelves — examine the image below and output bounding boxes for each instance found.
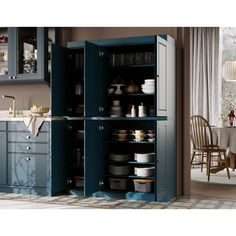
[52,35,176,201]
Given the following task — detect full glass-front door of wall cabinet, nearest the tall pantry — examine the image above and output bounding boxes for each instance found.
[13,27,45,81]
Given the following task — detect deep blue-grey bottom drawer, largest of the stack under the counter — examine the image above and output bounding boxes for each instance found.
[8,153,51,187]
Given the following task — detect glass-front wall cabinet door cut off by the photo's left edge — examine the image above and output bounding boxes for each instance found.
[0,28,11,79]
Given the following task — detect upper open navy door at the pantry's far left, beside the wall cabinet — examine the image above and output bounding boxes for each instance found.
[50,45,68,116]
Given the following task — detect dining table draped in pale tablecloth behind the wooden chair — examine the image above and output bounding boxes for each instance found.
[211,126,236,169]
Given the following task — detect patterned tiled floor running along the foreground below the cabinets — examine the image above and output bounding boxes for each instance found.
[0,193,236,209]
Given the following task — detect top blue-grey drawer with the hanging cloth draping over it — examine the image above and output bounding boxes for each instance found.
[8,132,50,143]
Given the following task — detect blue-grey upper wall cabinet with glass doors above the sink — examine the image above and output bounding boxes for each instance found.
[0,27,48,83]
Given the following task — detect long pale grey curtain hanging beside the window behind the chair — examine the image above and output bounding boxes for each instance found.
[190,27,221,125]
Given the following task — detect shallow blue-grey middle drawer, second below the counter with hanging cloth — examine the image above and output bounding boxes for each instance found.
[8,142,49,154]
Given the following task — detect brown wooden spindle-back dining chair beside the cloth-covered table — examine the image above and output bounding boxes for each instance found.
[190,115,230,181]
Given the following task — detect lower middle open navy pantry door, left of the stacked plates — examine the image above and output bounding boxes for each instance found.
[84,120,105,196]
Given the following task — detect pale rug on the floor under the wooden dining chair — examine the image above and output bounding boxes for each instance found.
[191,168,236,186]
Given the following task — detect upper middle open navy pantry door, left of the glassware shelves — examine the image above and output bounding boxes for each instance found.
[85,41,106,117]
